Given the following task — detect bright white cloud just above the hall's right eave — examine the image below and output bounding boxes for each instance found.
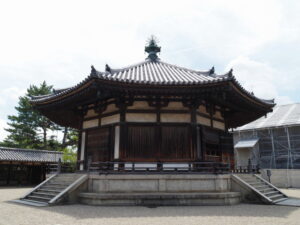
[226,56,292,104]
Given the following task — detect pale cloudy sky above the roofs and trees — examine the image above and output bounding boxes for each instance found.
[0,0,300,140]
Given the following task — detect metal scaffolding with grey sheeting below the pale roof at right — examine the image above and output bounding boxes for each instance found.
[234,125,300,169]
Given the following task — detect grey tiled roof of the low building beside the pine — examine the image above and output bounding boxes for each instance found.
[0,147,62,162]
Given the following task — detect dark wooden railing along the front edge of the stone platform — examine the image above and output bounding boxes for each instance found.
[88,162,230,174]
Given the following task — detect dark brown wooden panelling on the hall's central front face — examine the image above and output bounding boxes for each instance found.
[121,124,193,161]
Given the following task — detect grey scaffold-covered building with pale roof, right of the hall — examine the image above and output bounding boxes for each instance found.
[234,103,300,169]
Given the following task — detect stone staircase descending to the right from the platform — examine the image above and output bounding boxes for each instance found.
[232,174,288,204]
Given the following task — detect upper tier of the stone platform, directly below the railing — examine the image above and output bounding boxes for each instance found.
[88,174,231,193]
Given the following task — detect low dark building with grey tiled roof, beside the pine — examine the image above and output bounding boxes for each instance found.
[0,147,62,185]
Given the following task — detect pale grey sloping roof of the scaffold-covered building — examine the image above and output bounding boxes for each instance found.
[237,103,300,131]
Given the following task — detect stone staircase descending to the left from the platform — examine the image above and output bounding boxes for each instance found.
[15,173,88,206]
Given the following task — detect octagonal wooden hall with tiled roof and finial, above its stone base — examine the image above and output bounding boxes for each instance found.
[31,39,274,170]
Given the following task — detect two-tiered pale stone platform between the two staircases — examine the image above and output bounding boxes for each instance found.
[78,174,241,206]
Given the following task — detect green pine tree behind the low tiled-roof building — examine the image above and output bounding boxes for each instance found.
[0,81,78,151]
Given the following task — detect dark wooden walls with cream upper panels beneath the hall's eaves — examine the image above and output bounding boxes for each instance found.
[78,98,237,167]
